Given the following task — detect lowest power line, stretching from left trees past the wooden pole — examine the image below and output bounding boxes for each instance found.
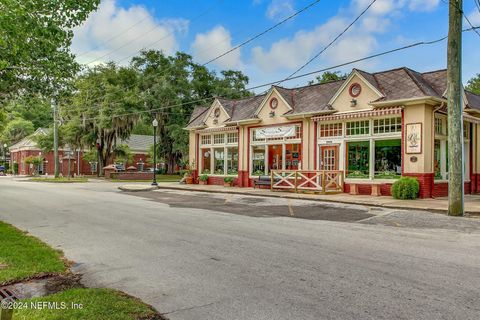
[71,27,480,121]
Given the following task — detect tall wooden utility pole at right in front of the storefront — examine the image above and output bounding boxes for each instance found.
[447,0,464,216]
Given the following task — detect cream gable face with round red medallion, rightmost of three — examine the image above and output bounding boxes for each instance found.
[332,75,380,112]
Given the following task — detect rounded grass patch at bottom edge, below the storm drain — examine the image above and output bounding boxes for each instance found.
[13,288,161,320]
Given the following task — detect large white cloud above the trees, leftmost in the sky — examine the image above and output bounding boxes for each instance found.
[72,0,189,64]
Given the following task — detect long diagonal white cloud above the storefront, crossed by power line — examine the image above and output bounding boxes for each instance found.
[252,0,439,72]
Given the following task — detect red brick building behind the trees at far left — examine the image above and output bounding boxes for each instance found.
[9,128,153,176]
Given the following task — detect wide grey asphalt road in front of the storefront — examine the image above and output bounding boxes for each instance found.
[0,178,480,320]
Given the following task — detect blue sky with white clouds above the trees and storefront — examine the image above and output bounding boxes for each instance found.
[72,0,480,91]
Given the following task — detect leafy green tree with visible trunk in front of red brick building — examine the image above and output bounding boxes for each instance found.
[61,63,143,175]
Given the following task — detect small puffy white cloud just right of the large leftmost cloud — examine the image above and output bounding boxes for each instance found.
[192,26,242,69]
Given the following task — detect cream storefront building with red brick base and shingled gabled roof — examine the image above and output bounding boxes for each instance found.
[186,68,480,197]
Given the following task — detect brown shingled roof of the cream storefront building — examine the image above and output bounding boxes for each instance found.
[187,67,480,129]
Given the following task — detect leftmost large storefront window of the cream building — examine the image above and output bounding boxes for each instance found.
[200,132,238,175]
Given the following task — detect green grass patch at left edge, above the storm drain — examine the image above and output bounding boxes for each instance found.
[0,222,66,284]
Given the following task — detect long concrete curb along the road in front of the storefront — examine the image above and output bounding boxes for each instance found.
[156,186,480,217]
